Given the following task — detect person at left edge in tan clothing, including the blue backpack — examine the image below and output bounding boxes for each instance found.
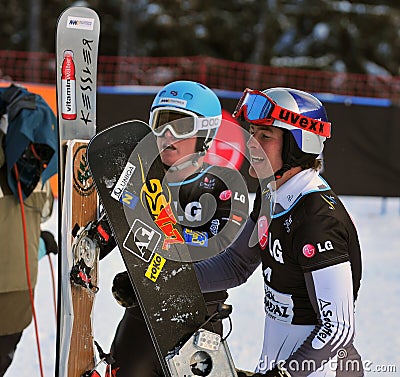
[0,84,57,376]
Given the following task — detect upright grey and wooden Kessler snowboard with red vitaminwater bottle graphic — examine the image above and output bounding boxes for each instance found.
[56,7,100,377]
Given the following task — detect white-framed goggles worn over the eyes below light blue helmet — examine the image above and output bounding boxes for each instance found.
[150,106,222,139]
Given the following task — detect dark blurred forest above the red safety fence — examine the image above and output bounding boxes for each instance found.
[0,0,400,76]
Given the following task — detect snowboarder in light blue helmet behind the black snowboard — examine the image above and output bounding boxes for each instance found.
[111,81,248,377]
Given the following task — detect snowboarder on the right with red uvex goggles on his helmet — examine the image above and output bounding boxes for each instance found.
[196,88,363,377]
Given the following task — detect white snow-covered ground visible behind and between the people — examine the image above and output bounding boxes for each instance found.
[5,197,400,377]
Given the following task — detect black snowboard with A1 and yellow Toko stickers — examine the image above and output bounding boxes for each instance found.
[87,120,236,377]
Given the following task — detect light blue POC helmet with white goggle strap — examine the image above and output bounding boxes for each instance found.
[149,81,222,153]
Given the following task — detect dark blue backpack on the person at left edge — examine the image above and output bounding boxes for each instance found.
[0,84,58,199]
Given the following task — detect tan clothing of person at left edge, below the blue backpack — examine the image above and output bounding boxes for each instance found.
[0,158,56,376]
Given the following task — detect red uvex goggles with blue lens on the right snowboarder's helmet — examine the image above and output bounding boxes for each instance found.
[232,88,331,138]
